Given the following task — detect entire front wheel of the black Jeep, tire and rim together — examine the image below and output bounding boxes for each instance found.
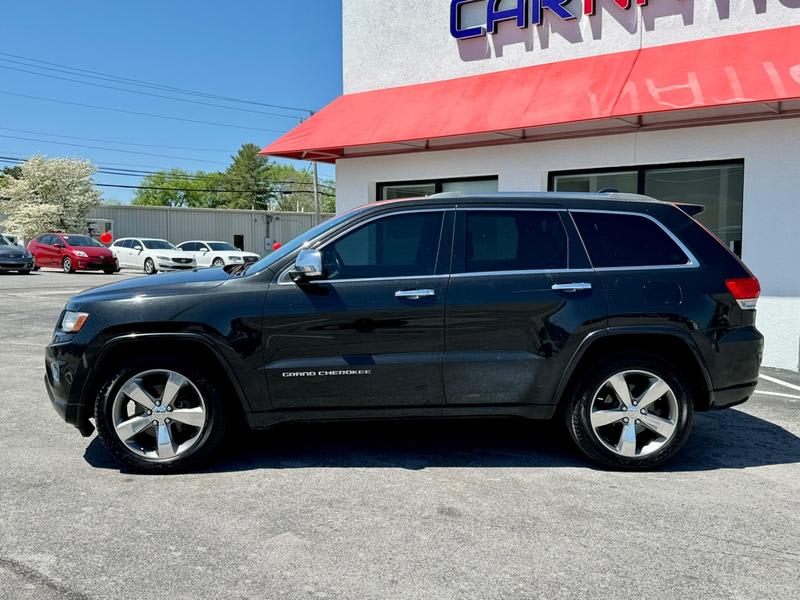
[94,357,231,473]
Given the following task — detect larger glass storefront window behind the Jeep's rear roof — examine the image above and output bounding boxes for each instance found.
[549,161,744,256]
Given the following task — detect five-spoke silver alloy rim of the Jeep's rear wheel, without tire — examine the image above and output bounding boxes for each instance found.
[589,371,678,458]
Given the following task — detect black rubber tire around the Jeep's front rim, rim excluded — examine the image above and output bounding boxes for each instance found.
[94,356,228,474]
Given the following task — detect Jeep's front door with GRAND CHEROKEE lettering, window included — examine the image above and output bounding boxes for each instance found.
[264,210,453,409]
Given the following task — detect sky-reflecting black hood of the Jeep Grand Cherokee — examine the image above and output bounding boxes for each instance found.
[69,269,231,305]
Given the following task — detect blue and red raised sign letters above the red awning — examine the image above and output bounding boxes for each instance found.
[450,0,647,40]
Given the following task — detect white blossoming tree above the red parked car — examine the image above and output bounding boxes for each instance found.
[0,156,101,240]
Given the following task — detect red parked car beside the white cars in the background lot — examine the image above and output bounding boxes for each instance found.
[28,233,119,273]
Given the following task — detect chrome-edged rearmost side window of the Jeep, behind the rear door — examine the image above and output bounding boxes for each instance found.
[572,212,689,269]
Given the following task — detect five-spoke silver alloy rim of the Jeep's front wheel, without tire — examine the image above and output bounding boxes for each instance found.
[111,369,208,460]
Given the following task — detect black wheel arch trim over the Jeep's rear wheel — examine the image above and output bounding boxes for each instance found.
[553,327,713,411]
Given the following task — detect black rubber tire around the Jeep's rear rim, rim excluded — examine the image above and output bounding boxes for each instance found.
[564,352,694,471]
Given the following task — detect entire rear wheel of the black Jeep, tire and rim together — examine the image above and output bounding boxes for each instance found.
[565,353,694,470]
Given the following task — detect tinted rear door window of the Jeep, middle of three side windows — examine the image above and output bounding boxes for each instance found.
[464,210,568,273]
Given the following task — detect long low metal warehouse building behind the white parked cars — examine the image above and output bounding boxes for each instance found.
[89,206,331,255]
